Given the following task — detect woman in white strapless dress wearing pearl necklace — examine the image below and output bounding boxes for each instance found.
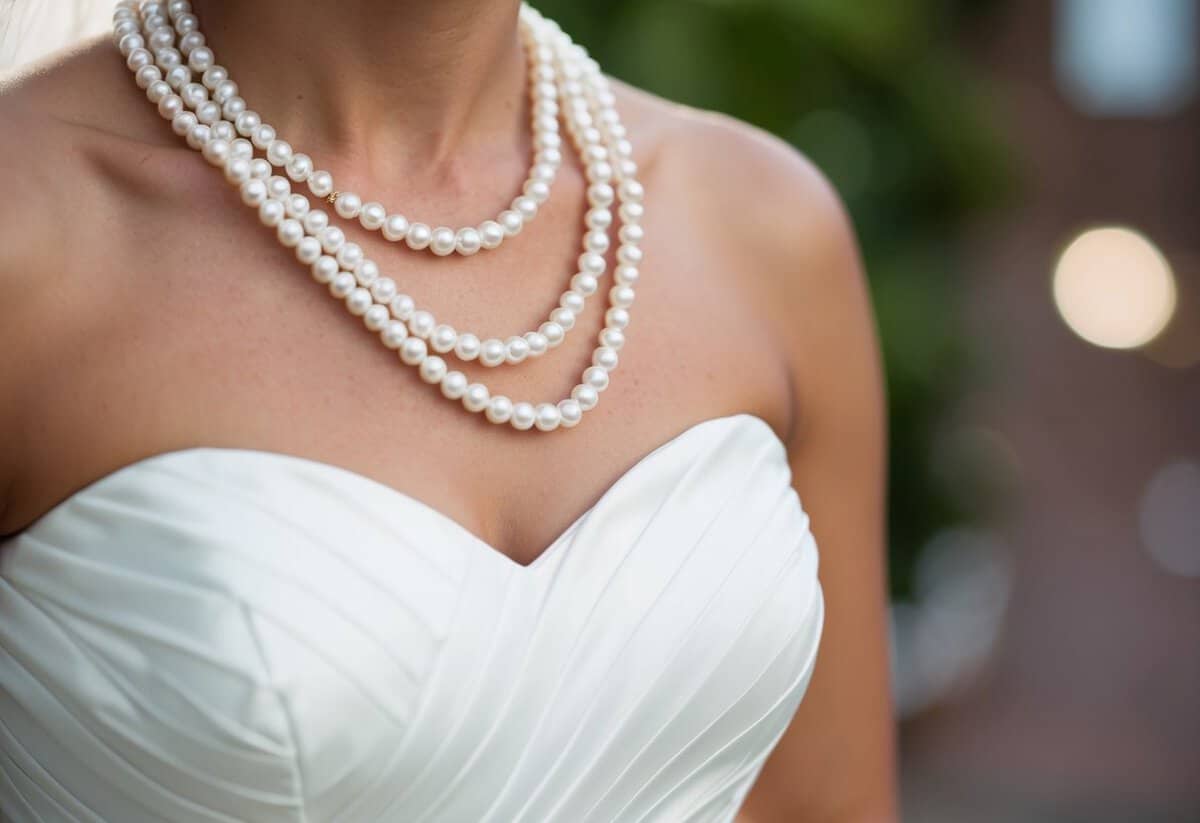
[0,0,896,823]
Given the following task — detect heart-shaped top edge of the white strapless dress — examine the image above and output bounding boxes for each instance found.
[16,412,786,575]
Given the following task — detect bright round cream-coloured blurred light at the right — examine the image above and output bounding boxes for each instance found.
[1054,227,1177,349]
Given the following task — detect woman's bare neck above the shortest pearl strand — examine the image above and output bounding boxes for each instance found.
[192,0,527,174]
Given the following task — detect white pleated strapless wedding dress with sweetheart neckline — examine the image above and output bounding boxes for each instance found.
[0,414,824,823]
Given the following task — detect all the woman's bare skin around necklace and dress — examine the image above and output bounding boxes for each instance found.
[0,0,898,823]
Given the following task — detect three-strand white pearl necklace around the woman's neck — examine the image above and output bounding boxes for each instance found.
[113,0,643,431]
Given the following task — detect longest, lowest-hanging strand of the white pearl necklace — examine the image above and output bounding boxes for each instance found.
[114,0,643,431]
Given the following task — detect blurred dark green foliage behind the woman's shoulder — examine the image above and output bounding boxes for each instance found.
[534,0,1010,597]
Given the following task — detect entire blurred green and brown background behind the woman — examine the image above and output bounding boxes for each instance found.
[0,0,1200,823]
